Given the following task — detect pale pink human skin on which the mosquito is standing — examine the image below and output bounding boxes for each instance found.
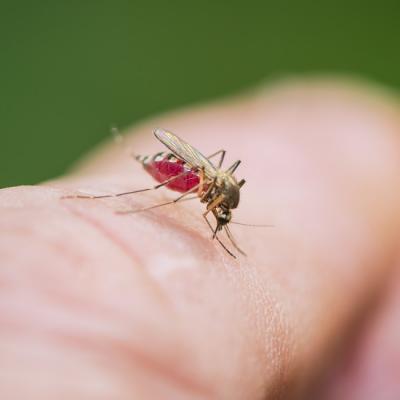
[0,80,400,400]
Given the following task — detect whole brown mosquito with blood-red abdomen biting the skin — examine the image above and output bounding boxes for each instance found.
[64,128,270,258]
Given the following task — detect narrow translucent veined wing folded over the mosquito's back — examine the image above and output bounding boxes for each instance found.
[154,128,216,178]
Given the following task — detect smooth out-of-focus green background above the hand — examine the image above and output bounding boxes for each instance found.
[0,0,400,187]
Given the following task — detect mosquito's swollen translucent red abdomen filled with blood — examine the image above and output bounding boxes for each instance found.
[143,155,200,193]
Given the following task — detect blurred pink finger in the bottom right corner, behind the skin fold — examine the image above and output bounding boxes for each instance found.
[319,262,400,400]
